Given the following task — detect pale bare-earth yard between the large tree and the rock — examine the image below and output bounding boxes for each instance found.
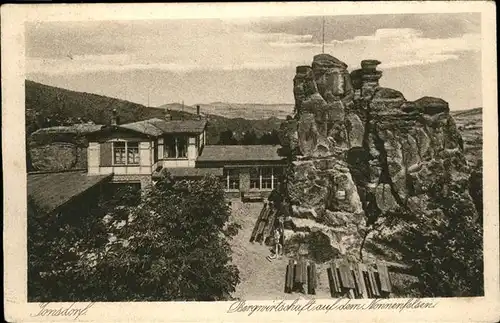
[230,200,330,300]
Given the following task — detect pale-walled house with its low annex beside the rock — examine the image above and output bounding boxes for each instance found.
[87,110,285,197]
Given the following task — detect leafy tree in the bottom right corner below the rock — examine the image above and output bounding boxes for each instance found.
[376,191,484,297]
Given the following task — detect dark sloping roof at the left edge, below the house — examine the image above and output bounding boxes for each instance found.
[28,170,112,213]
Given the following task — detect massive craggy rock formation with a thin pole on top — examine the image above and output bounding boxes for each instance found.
[280,54,478,260]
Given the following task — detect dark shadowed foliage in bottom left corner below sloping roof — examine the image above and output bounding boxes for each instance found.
[28,198,107,302]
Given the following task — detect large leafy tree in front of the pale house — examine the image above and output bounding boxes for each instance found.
[28,177,239,301]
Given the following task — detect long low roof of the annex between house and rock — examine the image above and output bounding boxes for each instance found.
[197,145,284,161]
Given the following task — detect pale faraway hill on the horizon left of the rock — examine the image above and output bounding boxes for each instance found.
[159,102,294,120]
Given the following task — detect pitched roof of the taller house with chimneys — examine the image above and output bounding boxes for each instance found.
[118,118,207,137]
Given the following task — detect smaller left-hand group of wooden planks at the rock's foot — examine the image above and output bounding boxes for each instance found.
[285,259,317,295]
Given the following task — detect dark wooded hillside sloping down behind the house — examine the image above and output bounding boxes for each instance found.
[25,80,281,144]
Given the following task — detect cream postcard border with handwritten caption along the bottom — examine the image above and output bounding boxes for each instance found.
[1,1,500,322]
